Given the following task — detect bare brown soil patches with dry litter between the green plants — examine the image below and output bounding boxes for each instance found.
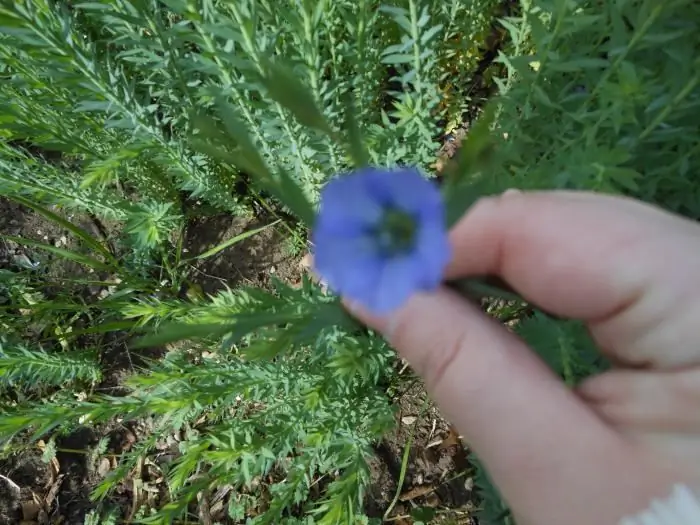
[0,184,475,525]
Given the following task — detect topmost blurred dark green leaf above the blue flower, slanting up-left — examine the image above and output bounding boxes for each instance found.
[260,60,333,136]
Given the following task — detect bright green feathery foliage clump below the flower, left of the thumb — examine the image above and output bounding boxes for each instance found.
[0,283,393,523]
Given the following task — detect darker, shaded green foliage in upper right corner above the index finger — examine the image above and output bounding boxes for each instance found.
[497,0,700,218]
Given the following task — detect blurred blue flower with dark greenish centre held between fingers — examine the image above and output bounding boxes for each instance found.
[312,168,450,315]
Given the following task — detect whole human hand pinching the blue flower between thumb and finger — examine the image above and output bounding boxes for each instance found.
[352,192,700,525]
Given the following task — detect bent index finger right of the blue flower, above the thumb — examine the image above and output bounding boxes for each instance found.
[447,191,700,366]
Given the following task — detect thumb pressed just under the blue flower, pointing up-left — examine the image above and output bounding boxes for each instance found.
[349,288,672,523]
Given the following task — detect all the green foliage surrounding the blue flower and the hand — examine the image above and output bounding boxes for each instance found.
[0,0,700,524]
